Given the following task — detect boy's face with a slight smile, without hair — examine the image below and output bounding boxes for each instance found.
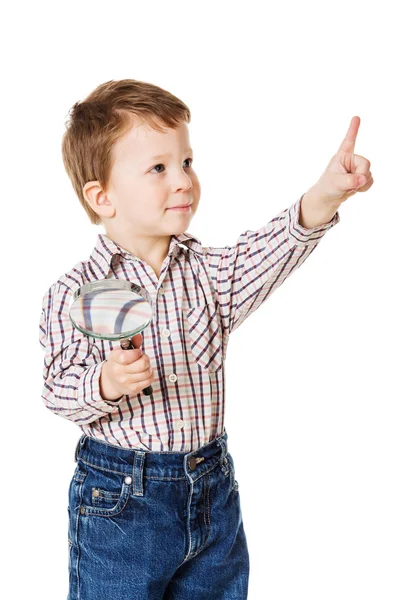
[93,122,201,238]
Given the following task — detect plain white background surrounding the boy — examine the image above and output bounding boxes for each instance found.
[1,0,400,600]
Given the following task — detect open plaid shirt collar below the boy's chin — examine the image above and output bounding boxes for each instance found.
[90,232,203,278]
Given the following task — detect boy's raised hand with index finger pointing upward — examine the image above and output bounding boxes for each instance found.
[310,117,374,207]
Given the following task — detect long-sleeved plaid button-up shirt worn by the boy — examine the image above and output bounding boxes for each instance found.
[39,197,340,452]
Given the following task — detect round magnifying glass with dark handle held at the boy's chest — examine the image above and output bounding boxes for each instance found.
[69,279,153,396]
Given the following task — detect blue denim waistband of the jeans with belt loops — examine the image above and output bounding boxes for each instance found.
[75,431,228,495]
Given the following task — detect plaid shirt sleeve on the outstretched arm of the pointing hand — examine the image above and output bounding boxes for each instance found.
[208,194,340,333]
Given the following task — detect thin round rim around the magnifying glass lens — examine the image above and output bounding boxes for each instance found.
[69,279,153,341]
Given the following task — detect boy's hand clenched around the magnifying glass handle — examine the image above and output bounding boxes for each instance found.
[100,333,154,400]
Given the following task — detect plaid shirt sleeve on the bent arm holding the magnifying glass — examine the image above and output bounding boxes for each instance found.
[39,283,124,425]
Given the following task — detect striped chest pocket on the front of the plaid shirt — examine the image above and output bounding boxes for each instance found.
[186,302,223,373]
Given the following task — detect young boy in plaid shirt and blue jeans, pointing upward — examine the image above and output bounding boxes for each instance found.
[40,79,373,600]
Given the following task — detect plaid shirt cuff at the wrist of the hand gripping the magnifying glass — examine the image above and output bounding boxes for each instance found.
[78,361,124,416]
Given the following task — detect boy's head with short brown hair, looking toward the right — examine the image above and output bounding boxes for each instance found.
[62,79,201,240]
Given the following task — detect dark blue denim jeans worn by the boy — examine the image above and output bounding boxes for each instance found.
[68,432,249,600]
